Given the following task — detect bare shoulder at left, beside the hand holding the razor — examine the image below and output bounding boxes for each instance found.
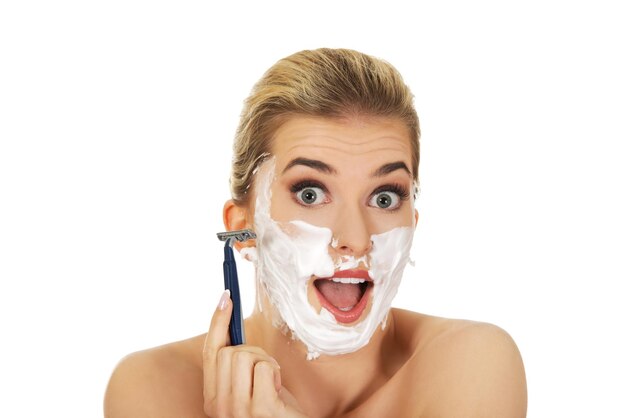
[104,336,205,418]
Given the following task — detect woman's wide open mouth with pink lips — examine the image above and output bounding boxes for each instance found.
[313,270,374,324]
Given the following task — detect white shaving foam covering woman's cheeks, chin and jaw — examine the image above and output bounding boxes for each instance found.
[244,158,414,359]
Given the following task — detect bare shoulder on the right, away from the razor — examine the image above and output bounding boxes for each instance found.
[392,311,527,418]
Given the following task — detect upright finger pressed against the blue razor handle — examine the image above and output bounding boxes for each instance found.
[202,290,232,415]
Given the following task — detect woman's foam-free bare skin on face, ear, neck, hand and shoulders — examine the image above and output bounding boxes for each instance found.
[104,117,527,418]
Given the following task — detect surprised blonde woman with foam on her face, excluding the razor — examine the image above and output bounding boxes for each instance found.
[105,49,526,418]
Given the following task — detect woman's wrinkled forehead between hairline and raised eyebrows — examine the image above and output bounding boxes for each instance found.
[272,116,411,171]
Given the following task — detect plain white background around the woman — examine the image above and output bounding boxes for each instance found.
[0,0,626,417]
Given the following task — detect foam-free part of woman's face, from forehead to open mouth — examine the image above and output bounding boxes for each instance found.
[271,117,417,316]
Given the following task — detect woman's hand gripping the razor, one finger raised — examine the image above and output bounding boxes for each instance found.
[203,291,305,418]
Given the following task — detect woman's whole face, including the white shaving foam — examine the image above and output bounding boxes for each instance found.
[243,117,417,358]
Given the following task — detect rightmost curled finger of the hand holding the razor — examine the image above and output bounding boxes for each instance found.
[252,361,280,416]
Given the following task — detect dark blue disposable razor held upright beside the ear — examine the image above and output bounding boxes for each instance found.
[217,229,256,345]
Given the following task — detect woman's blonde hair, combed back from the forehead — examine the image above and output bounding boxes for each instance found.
[230,48,420,205]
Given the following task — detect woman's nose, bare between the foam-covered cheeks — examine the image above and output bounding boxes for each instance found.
[333,202,372,258]
